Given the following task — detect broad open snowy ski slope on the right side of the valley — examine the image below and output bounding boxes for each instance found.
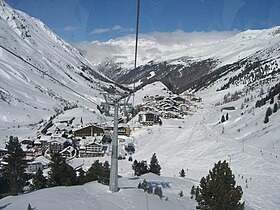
[127,79,280,210]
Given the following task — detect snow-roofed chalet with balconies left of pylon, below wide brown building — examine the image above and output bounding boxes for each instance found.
[79,142,104,157]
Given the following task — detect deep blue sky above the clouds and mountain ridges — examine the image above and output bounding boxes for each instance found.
[6,0,280,42]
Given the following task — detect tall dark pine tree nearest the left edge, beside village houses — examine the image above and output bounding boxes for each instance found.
[3,136,27,193]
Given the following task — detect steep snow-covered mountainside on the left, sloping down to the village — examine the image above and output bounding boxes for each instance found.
[0,1,125,141]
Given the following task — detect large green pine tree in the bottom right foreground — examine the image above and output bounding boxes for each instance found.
[196,161,244,210]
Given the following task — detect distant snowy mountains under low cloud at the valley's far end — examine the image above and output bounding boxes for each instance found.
[77,27,280,92]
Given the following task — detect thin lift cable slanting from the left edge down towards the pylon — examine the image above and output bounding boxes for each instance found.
[0,45,106,122]
